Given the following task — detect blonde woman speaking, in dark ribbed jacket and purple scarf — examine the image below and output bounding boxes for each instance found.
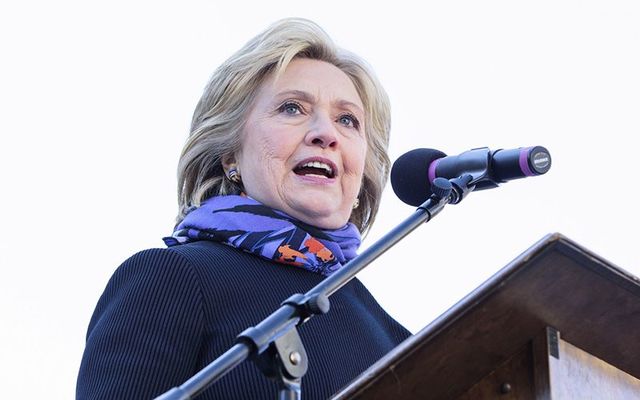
[77,19,409,399]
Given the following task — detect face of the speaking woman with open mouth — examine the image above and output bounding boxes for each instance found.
[235,59,367,229]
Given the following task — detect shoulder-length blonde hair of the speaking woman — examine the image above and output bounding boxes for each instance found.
[177,18,391,234]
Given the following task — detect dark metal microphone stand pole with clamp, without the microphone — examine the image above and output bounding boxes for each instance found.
[155,175,473,400]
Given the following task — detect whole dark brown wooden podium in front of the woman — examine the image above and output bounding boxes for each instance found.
[333,234,640,400]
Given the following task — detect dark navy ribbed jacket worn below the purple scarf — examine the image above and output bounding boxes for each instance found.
[76,241,410,400]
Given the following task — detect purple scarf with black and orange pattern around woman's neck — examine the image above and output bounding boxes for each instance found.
[163,196,360,276]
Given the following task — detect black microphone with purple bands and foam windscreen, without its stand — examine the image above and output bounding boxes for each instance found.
[391,146,551,207]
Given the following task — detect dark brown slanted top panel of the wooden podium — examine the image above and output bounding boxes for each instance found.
[334,233,640,399]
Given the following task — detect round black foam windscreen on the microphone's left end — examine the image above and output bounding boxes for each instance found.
[391,149,447,207]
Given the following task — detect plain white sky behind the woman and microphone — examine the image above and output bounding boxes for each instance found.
[0,0,640,399]
